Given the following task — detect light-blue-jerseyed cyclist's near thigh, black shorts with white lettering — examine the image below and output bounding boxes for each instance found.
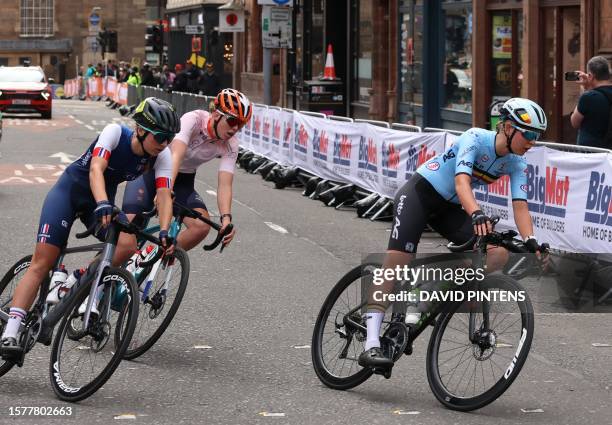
[387,174,427,253]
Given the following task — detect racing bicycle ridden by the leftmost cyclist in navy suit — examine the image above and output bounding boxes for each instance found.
[0,208,161,402]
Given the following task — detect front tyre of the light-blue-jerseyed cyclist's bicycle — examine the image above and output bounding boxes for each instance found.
[427,275,534,412]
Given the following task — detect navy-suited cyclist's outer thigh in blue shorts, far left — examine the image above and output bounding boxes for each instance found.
[36,174,82,248]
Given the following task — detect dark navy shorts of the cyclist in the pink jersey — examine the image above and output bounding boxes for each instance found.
[121,171,208,214]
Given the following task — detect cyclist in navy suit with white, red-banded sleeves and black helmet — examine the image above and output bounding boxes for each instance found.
[0,97,180,358]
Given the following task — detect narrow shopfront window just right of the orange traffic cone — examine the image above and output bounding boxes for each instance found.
[353,0,374,102]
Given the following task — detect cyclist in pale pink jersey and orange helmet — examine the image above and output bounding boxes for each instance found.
[123,89,253,250]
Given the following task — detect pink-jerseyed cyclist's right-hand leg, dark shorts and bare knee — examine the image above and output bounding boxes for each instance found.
[174,173,210,251]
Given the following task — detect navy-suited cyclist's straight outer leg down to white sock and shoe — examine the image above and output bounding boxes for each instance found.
[1,176,75,353]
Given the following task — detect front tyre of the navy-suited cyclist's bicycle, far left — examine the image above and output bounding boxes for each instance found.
[49,267,139,402]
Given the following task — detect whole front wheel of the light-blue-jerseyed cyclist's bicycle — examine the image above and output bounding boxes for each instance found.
[427,275,534,411]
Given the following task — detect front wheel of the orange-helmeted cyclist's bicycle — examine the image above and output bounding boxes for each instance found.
[121,247,190,360]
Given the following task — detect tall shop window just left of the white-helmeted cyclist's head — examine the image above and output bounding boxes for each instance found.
[442,2,472,112]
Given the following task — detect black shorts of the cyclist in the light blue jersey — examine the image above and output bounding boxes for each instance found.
[388,173,474,253]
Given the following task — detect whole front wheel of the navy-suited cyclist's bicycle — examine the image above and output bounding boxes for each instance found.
[49,267,138,402]
